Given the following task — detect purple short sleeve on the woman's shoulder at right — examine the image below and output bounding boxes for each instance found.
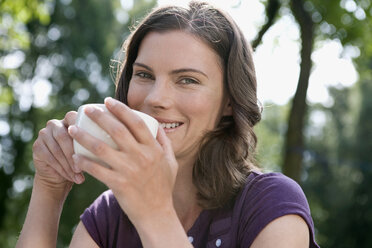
[239,173,319,248]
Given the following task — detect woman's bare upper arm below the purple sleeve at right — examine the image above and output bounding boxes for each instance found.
[251,215,310,248]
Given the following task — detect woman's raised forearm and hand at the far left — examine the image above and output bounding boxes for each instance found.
[17,111,84,247]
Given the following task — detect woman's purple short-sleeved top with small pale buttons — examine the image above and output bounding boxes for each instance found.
[80,172,319,248]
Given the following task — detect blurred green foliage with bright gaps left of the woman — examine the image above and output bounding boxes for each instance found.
[0,0,155,248]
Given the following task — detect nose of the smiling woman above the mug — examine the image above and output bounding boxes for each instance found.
[145,79,173,109]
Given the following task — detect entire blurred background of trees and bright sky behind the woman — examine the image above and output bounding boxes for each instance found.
[0,0,372,248]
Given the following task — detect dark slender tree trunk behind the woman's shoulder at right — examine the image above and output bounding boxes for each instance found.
[282,0,314,182]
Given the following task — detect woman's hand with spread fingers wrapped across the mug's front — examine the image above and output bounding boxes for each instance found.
[69,98,178,224]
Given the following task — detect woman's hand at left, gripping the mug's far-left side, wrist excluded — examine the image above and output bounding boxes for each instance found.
[32,111,84,189]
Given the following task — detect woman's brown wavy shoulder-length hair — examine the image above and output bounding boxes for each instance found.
[115,1,261,209]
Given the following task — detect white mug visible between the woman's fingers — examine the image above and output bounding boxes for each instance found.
[73,103,159,166]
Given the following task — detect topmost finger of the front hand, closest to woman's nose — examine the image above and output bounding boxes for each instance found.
[105,97,155,144]
